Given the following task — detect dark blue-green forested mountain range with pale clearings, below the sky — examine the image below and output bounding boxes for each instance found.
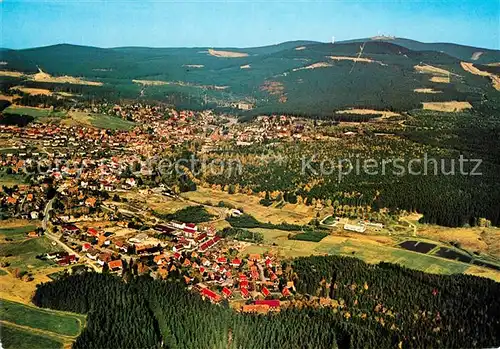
[0,38,500,116]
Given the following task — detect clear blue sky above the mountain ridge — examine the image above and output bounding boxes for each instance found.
[0,0,500,49]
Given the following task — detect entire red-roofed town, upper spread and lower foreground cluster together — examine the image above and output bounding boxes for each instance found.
[0,103,344,312]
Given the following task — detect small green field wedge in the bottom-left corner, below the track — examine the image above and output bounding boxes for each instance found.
[2,324,63,349]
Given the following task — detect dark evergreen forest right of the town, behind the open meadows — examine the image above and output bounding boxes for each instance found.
[201,109,500,227]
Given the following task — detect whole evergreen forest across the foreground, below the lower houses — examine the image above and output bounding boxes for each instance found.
[33,256,500,349]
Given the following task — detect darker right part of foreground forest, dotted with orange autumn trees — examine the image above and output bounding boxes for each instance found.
[289,256,500,348]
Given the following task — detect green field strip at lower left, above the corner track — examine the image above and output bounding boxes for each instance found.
[0,299,85,337]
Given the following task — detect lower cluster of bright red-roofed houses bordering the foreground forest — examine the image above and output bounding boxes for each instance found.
[57,218,294,312]
